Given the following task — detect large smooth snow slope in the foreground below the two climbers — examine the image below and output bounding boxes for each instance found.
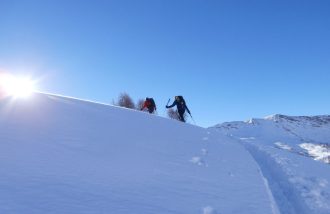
[0,94,278,214]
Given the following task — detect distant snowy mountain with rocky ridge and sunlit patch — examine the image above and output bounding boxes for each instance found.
[215,114,330,163]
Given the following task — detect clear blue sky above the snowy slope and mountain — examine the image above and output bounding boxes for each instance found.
[0,0,330,127]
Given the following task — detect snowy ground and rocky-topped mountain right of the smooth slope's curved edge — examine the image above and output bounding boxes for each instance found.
[210,115,330,214]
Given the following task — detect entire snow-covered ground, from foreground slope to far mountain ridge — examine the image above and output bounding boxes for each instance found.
[0,93,330,214]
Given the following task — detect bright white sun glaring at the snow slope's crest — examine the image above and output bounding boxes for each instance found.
[0,75,35,98]
